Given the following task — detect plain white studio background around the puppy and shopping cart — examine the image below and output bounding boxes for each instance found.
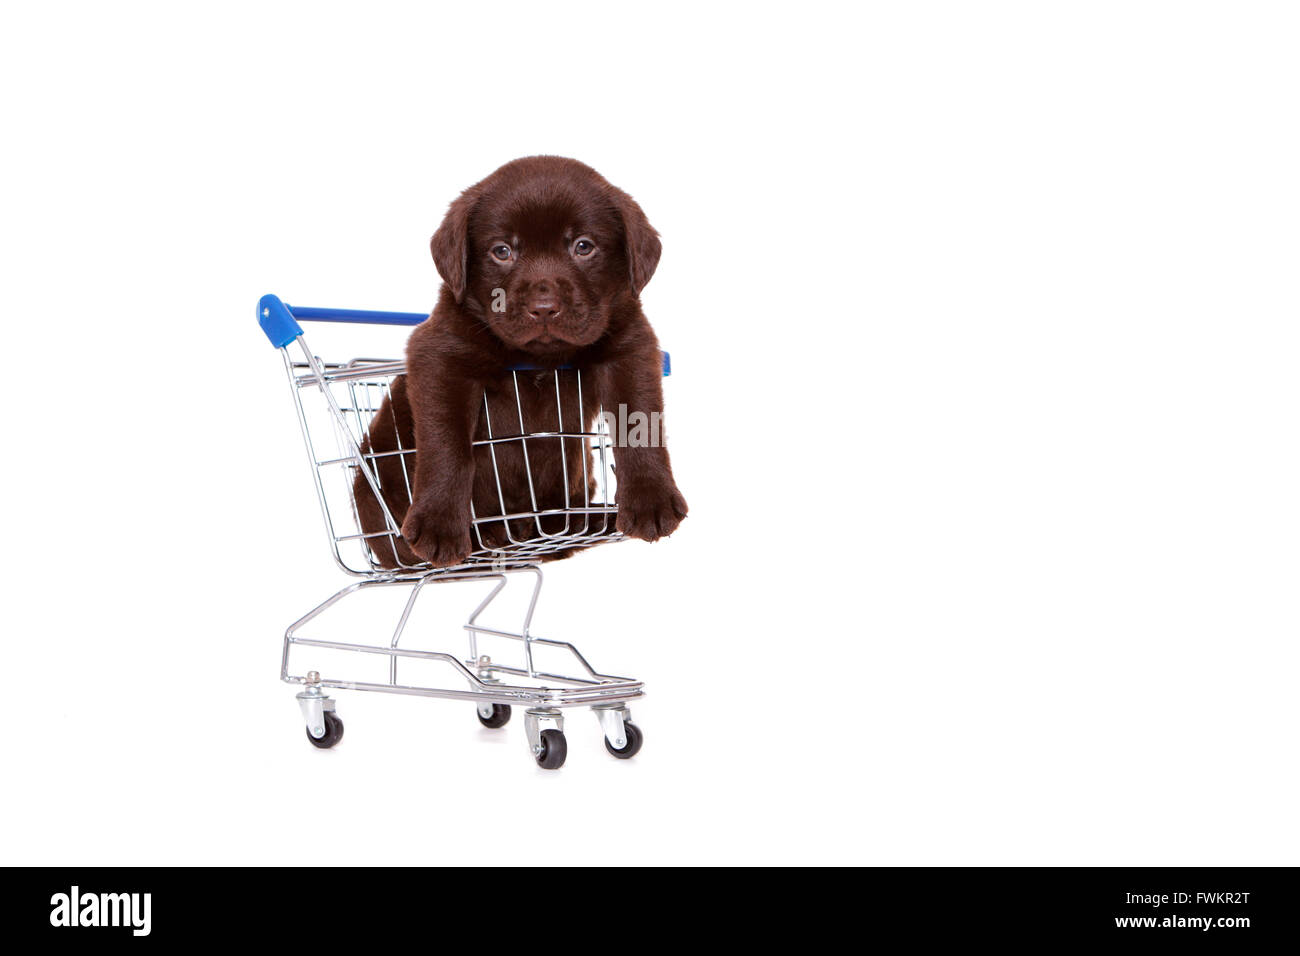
[0,3,1300,865]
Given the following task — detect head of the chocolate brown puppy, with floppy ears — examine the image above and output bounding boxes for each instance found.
[430,156,660,354]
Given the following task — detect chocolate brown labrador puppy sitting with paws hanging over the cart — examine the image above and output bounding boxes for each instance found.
[354,156,686,567]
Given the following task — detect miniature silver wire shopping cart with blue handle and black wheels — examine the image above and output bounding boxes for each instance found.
[257,295,668,770]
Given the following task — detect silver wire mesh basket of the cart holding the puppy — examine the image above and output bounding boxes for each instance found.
[281,348,623,576]
